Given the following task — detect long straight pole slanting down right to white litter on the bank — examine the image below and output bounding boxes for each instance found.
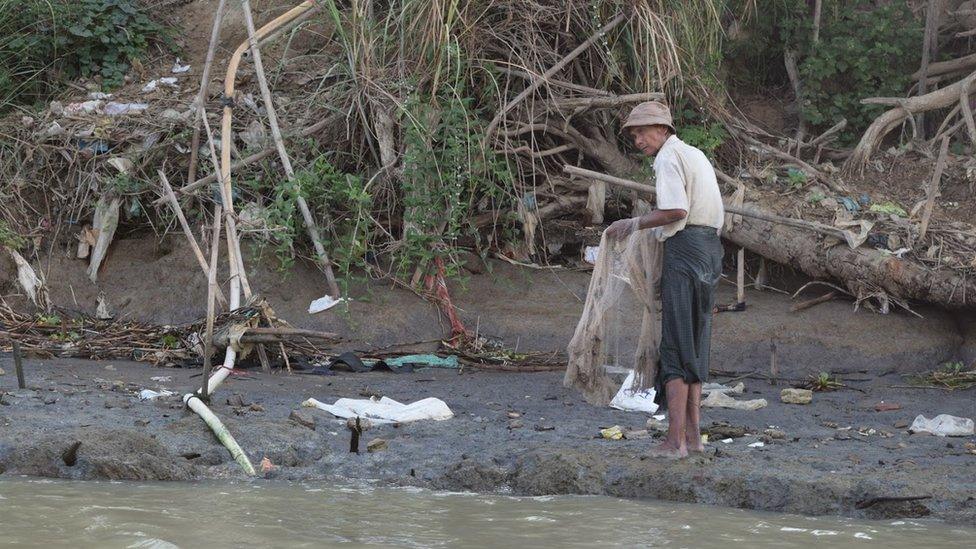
[241,0,341,297]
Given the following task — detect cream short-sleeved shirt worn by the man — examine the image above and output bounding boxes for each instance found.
[654,135,725,242]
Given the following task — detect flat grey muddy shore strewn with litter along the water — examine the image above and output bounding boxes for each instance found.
[0,354,976,525]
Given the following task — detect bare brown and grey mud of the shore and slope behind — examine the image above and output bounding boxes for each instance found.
[0,239,976,524]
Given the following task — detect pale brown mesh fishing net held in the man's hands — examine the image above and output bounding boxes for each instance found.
[563,230,663,406]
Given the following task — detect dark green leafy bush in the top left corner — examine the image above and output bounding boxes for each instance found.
[0,0,172,110]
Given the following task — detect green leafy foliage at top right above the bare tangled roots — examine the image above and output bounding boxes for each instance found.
[725,0,923,144]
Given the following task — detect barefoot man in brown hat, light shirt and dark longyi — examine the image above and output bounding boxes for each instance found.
[607,101,725,457]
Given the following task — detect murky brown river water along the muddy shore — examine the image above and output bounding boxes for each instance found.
[0,479,976,549]
